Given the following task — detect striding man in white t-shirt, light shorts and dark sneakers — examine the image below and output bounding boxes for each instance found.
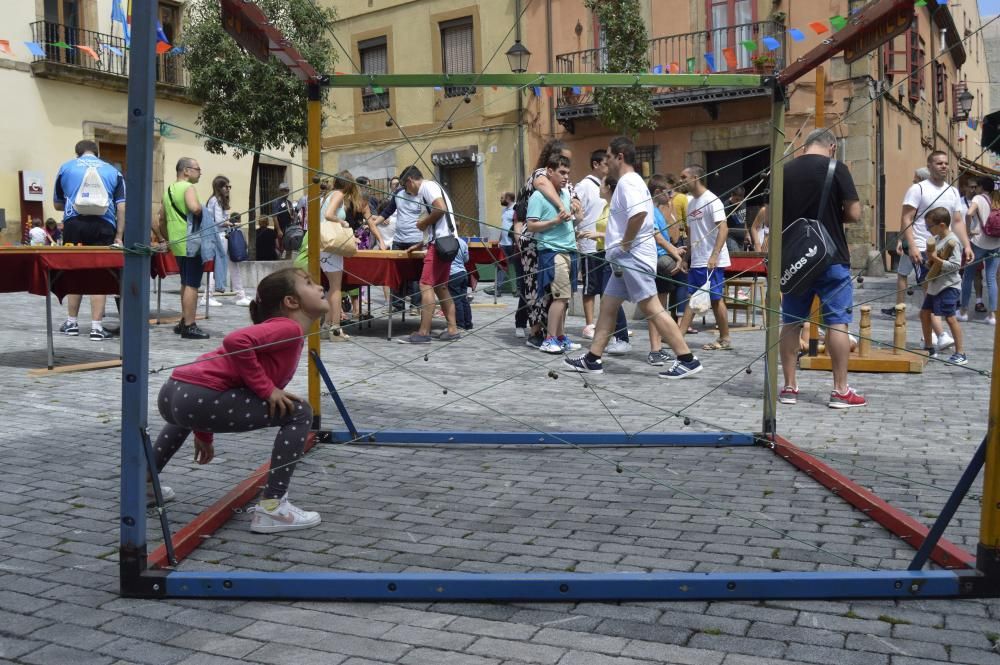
[563,136,702,379]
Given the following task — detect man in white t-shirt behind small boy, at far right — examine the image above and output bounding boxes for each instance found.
[896,150,972,348]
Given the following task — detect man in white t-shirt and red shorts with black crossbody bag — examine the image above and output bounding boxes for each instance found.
[396,166,461,344]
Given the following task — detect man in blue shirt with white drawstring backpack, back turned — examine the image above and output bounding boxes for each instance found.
[52,140,125,341]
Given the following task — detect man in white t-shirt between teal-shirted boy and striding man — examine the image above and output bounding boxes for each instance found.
[576,150,608,339]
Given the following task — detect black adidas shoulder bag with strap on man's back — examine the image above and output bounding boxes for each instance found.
[781,159,837,296]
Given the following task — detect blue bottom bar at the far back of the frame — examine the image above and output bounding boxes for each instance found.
[330,430,756,446]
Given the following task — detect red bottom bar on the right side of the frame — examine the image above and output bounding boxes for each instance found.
[774,436,976,569]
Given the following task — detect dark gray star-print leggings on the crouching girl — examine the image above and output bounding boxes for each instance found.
[153,379,312,499]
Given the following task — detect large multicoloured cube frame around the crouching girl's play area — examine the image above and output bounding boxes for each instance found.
[120,0,1000,602]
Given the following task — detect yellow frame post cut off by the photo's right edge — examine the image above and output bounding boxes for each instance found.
[976,308,1000,582]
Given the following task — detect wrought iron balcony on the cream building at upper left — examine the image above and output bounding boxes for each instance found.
[31,21,189,93]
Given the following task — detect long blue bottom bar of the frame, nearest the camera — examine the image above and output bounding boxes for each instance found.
[166,570,959,602]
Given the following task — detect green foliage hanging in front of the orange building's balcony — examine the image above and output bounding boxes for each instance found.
[584,0,656,138]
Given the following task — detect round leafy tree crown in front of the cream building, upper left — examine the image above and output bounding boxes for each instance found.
[180,0,336,157]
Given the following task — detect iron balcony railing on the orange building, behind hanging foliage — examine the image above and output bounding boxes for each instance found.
[556,21,785,106]
